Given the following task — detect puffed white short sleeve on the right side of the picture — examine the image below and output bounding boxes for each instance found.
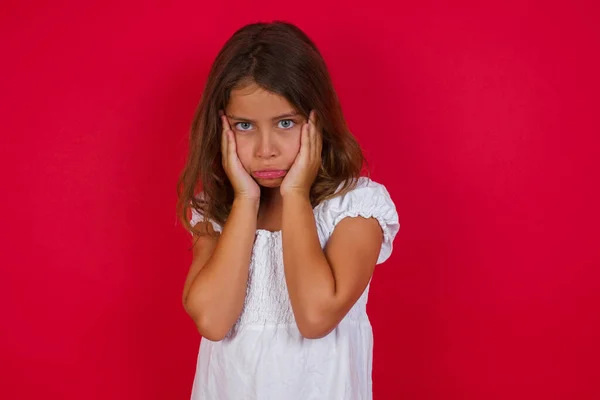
[318,177,400,264]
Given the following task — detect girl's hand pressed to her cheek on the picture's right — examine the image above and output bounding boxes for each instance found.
[279,110,323,197]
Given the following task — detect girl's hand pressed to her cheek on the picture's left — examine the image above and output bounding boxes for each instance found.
[221,115,260,200]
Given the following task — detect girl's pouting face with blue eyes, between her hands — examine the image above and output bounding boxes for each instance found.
[225,83,306,188]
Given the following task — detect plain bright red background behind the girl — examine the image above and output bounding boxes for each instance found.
[0,0,600,400]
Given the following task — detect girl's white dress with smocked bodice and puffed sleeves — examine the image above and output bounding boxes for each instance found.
[191,177,400,400]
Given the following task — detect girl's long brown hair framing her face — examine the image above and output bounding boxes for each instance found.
[177,21,365,234]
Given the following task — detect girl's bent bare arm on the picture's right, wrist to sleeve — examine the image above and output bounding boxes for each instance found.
[282,192,383,339]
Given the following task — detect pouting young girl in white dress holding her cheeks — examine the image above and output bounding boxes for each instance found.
[178,22,399,400]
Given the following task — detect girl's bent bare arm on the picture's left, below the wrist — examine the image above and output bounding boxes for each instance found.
[183,197,259,341]
